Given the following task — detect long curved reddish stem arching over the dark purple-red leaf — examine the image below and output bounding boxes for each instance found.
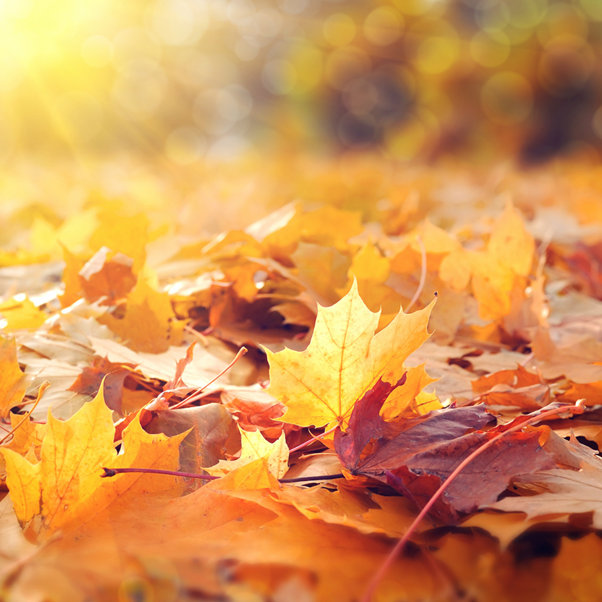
[361,400,583,602]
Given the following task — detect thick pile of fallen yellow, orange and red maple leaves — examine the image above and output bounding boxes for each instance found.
[0,162,602,602]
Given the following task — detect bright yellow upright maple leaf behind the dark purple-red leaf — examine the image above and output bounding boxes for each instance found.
[266,282,434,427]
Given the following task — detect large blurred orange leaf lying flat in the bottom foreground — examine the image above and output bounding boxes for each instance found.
[5,481,437,602]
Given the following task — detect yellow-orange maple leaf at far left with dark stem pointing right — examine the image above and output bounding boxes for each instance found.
[2,388,188,534]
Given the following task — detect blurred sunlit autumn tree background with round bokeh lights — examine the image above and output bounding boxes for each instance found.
[0,0,602,168]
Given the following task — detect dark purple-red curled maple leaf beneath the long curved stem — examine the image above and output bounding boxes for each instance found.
[334,379,556,523]
